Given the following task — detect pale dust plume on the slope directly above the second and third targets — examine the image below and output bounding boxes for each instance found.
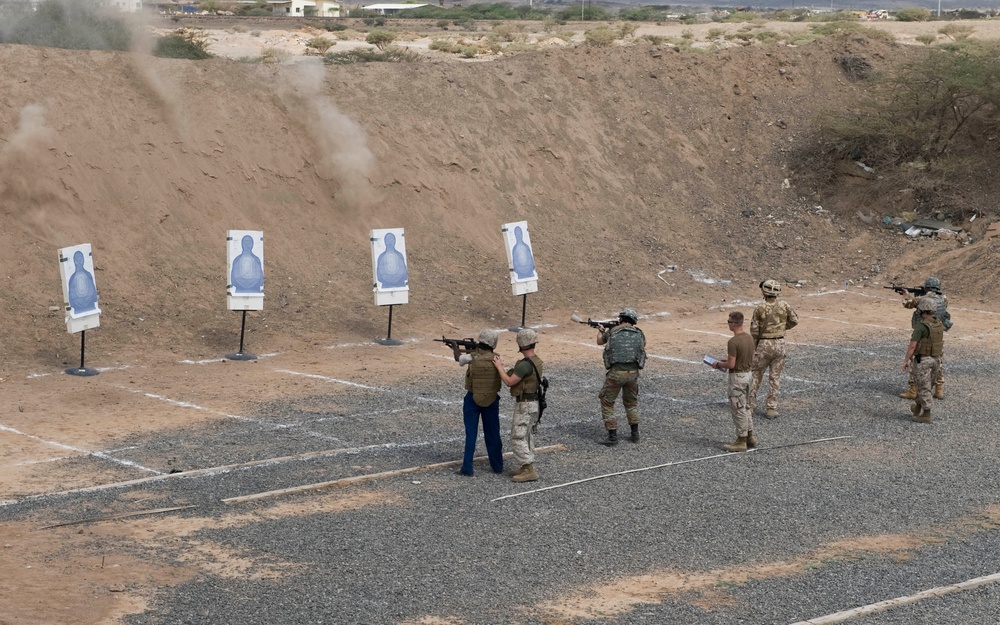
[287,62,375,211]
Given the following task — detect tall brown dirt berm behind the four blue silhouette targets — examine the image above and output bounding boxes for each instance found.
[0,38,998,367]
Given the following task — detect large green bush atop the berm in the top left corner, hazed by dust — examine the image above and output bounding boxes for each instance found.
[0,0,131,50]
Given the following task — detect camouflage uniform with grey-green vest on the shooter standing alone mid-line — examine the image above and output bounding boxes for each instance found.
[597,323,646,430]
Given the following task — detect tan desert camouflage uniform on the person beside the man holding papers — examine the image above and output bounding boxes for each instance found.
[750,297,799,412]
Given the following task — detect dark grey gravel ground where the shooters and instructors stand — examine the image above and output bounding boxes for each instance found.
[0,341,1000,625]
